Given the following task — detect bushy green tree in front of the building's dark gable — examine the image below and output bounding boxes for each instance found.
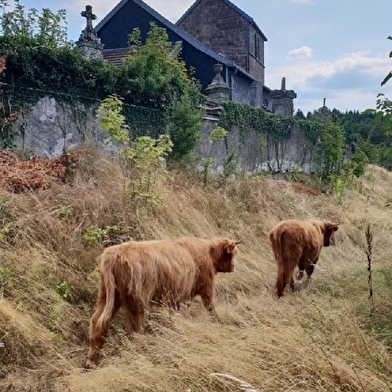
[119,22,205,160]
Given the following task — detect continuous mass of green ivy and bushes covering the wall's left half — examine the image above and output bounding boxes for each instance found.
[0,11,205,160]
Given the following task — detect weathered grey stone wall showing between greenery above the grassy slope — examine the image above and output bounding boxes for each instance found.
[3,98,314,174]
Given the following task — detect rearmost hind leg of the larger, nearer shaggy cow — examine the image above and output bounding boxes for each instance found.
[85,290,120,368]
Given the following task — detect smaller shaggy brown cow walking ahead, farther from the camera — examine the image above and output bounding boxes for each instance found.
[269,220,338,297]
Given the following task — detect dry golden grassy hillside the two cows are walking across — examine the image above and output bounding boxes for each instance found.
[0,147,392,392]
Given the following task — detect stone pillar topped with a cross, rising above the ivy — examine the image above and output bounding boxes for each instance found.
[76,5,103,60]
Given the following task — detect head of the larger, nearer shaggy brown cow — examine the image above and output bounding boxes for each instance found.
[210,238,241,272]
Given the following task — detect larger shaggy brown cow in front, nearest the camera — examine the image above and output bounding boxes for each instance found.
[86,237,239,367]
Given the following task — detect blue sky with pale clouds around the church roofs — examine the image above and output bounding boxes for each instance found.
[5,0,392,114]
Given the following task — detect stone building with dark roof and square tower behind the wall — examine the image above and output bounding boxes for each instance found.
[95,0,296,115]
